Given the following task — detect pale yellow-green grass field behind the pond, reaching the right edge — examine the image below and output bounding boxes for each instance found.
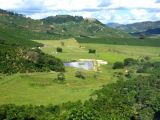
[36,38,160,63]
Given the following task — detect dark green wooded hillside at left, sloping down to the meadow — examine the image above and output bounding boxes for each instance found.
[0,10,64,74]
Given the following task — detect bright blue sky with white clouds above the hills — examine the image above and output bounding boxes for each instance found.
[0,0,160,24]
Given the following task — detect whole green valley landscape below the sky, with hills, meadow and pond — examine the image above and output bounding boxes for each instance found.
[0,9,160,120]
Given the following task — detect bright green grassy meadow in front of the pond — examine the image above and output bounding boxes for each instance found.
[0,69,114,105]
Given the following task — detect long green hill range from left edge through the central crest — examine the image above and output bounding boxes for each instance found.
[0,10,130,43]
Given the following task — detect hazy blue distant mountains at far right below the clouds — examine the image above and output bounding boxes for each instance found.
[110,21,160,36]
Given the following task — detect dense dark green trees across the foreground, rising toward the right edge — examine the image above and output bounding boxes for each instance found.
[0,62,160,120]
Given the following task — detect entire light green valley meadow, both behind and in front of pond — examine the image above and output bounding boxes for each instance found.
[0,38,160,105]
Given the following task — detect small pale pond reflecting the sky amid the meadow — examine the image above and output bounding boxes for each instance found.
[64,61,94,70]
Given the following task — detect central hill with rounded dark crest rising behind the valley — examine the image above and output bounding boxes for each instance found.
[41,15,129,37]
